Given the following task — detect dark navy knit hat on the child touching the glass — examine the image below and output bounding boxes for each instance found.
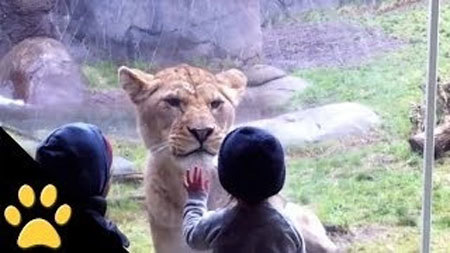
[218,127,286,204]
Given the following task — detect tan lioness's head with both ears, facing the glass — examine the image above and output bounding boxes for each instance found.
[119,65,247,168]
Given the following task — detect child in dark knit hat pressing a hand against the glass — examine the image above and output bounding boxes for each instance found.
[183,127,305,253]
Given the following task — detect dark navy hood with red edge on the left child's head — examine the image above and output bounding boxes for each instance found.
[36,122,112,198]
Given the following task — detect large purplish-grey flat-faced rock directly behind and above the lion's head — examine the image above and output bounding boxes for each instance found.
[54,0,262,62]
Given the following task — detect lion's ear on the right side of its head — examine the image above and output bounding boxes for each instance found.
[216,69,247,107]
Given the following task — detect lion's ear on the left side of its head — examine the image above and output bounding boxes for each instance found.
[118,66,158,104]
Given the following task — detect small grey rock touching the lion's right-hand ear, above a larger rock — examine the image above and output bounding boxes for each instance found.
[244,64,286,87]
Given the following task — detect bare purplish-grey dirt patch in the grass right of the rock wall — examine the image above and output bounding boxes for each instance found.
[263,22,401,70]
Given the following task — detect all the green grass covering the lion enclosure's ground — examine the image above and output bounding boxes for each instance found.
[83,1,450,252]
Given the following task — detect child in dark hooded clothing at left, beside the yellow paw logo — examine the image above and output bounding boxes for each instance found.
[36,123,129,253]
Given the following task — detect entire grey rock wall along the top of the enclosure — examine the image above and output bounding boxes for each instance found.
[0,0,343,64]
